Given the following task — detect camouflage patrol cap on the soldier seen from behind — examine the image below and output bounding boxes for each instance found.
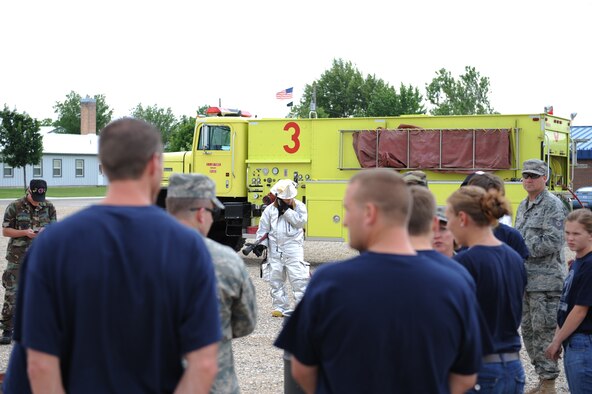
[167,174,224,209]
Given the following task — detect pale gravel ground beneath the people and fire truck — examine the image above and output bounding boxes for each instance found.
[0,199,569,394]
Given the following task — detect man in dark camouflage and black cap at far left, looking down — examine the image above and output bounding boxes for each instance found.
[0,179,57,345]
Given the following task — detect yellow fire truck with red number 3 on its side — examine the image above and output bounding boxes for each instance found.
[159,107,574,248]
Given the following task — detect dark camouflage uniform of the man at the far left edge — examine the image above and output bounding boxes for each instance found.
[0,196,56,331]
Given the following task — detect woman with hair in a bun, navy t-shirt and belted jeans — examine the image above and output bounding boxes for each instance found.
[446,186,526,393]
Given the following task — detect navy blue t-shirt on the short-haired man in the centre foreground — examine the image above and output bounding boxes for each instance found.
[275,253,482,393]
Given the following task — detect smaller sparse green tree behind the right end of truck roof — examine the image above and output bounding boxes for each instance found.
[426,66,494,115]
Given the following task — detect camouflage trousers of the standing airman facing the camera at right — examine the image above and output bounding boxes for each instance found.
[521,291,561,380]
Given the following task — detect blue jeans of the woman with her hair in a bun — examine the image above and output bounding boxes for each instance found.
[468,360,526,394]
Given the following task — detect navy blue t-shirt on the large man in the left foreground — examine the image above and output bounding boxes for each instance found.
[4,205,221,393]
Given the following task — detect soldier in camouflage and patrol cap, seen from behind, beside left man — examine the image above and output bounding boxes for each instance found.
[166,174,257,394]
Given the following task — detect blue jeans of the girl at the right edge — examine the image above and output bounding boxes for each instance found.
[563,334,592,394]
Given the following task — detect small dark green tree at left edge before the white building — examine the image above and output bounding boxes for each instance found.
[0,106,43,190]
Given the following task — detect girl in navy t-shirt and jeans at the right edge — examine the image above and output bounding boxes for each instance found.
[545,209,592,394]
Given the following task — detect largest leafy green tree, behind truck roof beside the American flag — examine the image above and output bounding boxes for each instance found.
[292,59,425,118]
